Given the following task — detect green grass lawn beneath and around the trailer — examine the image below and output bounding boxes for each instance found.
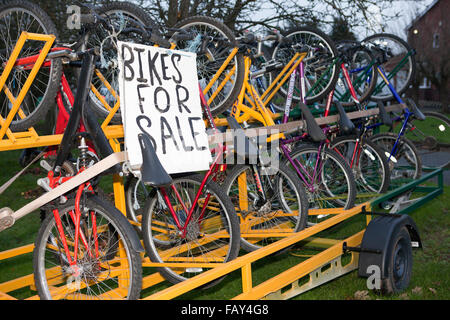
[0,151,450,300]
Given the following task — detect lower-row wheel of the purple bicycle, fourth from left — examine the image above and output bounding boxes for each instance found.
[283,143,356,211]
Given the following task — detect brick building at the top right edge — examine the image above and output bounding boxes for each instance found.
[406,0,450,105]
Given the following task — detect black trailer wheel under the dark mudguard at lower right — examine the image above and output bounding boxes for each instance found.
[381,227,413,294]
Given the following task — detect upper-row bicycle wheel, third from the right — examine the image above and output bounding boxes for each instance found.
[270,27,339,104]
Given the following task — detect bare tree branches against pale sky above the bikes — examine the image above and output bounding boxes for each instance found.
[140,0,399,32]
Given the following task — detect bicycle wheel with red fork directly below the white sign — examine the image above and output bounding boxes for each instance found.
[142,174,240,287]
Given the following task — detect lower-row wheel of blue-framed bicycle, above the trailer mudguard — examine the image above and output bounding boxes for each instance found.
[370,132,422,188]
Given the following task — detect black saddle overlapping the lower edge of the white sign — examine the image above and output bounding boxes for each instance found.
[138,133,172,187]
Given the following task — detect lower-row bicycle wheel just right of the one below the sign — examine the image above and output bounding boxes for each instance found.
[222,164,308,252]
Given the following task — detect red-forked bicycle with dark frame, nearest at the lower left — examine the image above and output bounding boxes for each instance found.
[29,49,143,299]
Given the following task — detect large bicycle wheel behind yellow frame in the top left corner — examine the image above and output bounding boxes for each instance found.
[0,0,62,131]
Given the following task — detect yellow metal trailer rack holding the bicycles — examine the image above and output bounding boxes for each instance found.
[0,33,422,300]
